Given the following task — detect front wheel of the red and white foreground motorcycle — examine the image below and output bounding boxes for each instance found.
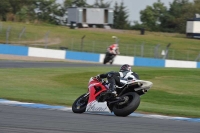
[72,94,89,113]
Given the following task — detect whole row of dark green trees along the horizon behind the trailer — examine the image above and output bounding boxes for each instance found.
[0,0,200,33]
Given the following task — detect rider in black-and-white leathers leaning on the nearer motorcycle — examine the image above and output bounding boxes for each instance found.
[96,64,139,94]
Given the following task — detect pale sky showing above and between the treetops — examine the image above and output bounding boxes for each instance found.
[57,0,184,22]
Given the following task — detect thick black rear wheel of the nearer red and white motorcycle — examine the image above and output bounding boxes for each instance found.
[113,92,140,117]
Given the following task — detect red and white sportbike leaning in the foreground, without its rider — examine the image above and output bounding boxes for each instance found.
[72,77,153,117]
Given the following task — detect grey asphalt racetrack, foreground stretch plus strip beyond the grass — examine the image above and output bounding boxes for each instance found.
[0,61,200,133]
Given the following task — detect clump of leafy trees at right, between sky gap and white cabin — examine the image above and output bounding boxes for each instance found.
[137,0,200,33]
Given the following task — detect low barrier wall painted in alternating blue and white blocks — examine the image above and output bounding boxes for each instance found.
[0,44,200,68]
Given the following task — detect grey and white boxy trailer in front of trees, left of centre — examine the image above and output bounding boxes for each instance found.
[68,7,114,28]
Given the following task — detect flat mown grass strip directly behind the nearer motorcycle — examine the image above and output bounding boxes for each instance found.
[0,67,200,117]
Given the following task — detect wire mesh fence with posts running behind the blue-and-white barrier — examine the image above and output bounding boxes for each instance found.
[0,23,200,61]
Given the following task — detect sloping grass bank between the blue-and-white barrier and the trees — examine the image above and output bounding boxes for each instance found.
[0,22,200,61]
